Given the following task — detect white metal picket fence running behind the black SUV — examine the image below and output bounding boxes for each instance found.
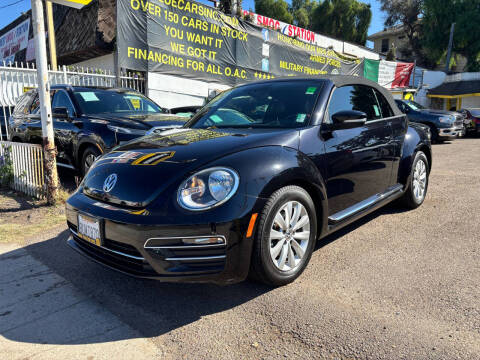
[0,62,145,140]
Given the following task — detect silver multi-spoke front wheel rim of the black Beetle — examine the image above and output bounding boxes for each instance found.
[270,201,310,271]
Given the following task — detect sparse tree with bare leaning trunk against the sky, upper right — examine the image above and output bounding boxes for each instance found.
[380,0,431,66]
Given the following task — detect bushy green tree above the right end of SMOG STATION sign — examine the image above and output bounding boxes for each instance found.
[310,0,372,45]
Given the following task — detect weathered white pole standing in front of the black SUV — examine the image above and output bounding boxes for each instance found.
[31,0,58,204]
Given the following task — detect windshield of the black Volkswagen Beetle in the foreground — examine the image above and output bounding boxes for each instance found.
[186,80,322,128]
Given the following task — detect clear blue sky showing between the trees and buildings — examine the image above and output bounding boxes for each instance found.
[0,0,385,47]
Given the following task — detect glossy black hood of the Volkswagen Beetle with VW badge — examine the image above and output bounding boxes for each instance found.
[82,128,299,207]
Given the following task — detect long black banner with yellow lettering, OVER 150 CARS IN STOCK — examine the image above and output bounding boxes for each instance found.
[117,0,363,85]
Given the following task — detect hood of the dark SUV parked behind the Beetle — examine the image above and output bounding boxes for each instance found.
[89,113,188,130]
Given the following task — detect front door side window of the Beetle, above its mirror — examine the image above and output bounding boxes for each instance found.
[327,85,382,123]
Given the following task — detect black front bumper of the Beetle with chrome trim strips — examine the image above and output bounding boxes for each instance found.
[66,194,262,284]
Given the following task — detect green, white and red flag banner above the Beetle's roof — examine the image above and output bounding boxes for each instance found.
[363,59,414,89]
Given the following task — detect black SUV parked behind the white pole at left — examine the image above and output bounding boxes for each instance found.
[9,85,185,175]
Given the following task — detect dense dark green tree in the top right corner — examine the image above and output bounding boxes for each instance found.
[422,0,480,71]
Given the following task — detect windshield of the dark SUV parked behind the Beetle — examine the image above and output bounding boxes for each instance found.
[73,89,165,115]
